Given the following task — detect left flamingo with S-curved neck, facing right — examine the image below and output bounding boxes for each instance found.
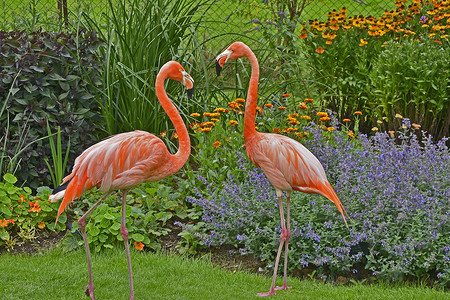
[50,61,194,299]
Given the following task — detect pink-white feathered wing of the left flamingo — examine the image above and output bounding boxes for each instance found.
[56,130,170,211]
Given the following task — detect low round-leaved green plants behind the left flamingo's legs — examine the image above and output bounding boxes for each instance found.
[64,183,187,252]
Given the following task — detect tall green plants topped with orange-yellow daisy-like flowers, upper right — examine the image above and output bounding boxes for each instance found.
[299,0,450,139]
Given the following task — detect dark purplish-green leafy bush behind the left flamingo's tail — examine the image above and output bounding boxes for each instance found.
[0,31,102,188]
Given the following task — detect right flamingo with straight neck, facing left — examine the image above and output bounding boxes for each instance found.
[216,42,348,296]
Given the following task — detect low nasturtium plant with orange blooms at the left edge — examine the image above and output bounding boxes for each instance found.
[0,173,67,249]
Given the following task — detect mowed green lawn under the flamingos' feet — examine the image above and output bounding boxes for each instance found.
[0,249,450,300]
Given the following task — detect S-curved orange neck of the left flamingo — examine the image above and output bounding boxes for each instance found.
[155,68,191,166]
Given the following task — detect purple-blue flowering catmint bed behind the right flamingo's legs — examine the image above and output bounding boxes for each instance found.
[187,118,450,286]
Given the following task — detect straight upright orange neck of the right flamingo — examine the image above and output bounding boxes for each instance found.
[244,47,259,142]
